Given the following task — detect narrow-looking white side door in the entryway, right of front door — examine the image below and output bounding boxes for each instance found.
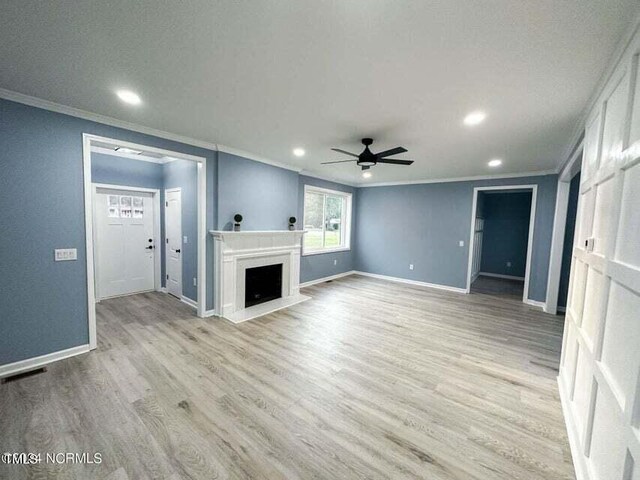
[165,189,182,298]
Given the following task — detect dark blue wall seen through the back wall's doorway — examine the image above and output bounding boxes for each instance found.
[480,192,531,278]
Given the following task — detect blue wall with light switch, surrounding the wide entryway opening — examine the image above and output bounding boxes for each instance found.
[0,100,217,365]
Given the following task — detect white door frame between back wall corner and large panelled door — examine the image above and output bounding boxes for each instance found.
[544,139,584,315]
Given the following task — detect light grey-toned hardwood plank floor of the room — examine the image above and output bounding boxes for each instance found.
[0,276,574,480]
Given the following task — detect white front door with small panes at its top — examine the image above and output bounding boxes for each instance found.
[94,188,155,300]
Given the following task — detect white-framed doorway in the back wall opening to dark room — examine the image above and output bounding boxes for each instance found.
[467,185,537,303]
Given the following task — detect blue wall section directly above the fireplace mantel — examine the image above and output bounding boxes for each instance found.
[218,152,298,230]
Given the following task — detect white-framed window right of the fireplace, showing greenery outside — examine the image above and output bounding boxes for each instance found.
[303,185,351,255]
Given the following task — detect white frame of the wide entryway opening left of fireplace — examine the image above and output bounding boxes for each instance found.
[82,133,207,350]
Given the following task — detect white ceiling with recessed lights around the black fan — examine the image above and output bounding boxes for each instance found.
[0,0,639,183]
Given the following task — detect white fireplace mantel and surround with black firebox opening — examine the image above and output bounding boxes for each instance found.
[209,230,309,323]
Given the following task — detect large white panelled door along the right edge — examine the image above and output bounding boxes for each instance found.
[560,45,640,480]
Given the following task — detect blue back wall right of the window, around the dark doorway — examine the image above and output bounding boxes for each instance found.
[355,175,557,301]
